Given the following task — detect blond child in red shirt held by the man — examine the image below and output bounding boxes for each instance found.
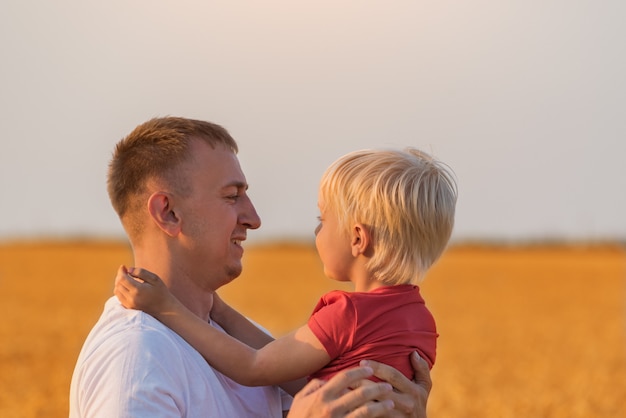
[115,148,457,394]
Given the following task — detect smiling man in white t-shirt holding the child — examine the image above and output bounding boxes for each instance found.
[70,117,430,418]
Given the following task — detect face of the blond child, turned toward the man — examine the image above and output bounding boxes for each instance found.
[315,198,353,282]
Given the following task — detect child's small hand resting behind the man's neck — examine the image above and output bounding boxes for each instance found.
[114,266,176,318]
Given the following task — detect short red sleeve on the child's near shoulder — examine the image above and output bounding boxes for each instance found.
[308,290,356,360]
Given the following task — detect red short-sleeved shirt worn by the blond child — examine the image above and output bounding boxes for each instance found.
[308,285,438,380]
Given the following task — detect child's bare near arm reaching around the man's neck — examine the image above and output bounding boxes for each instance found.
[115,269,330,395]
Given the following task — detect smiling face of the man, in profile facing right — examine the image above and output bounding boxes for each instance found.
[180,141,261,290]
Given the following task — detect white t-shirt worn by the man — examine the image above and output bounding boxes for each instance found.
[70,297,292,418]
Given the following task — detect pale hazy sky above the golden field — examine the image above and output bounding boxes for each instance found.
[0,0,626,242]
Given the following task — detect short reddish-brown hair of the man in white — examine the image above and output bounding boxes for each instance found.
[107,116,238,241]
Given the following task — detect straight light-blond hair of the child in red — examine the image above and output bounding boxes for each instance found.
[320,148,457,285]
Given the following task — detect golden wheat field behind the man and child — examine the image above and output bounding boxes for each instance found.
[0,242,626,418]
